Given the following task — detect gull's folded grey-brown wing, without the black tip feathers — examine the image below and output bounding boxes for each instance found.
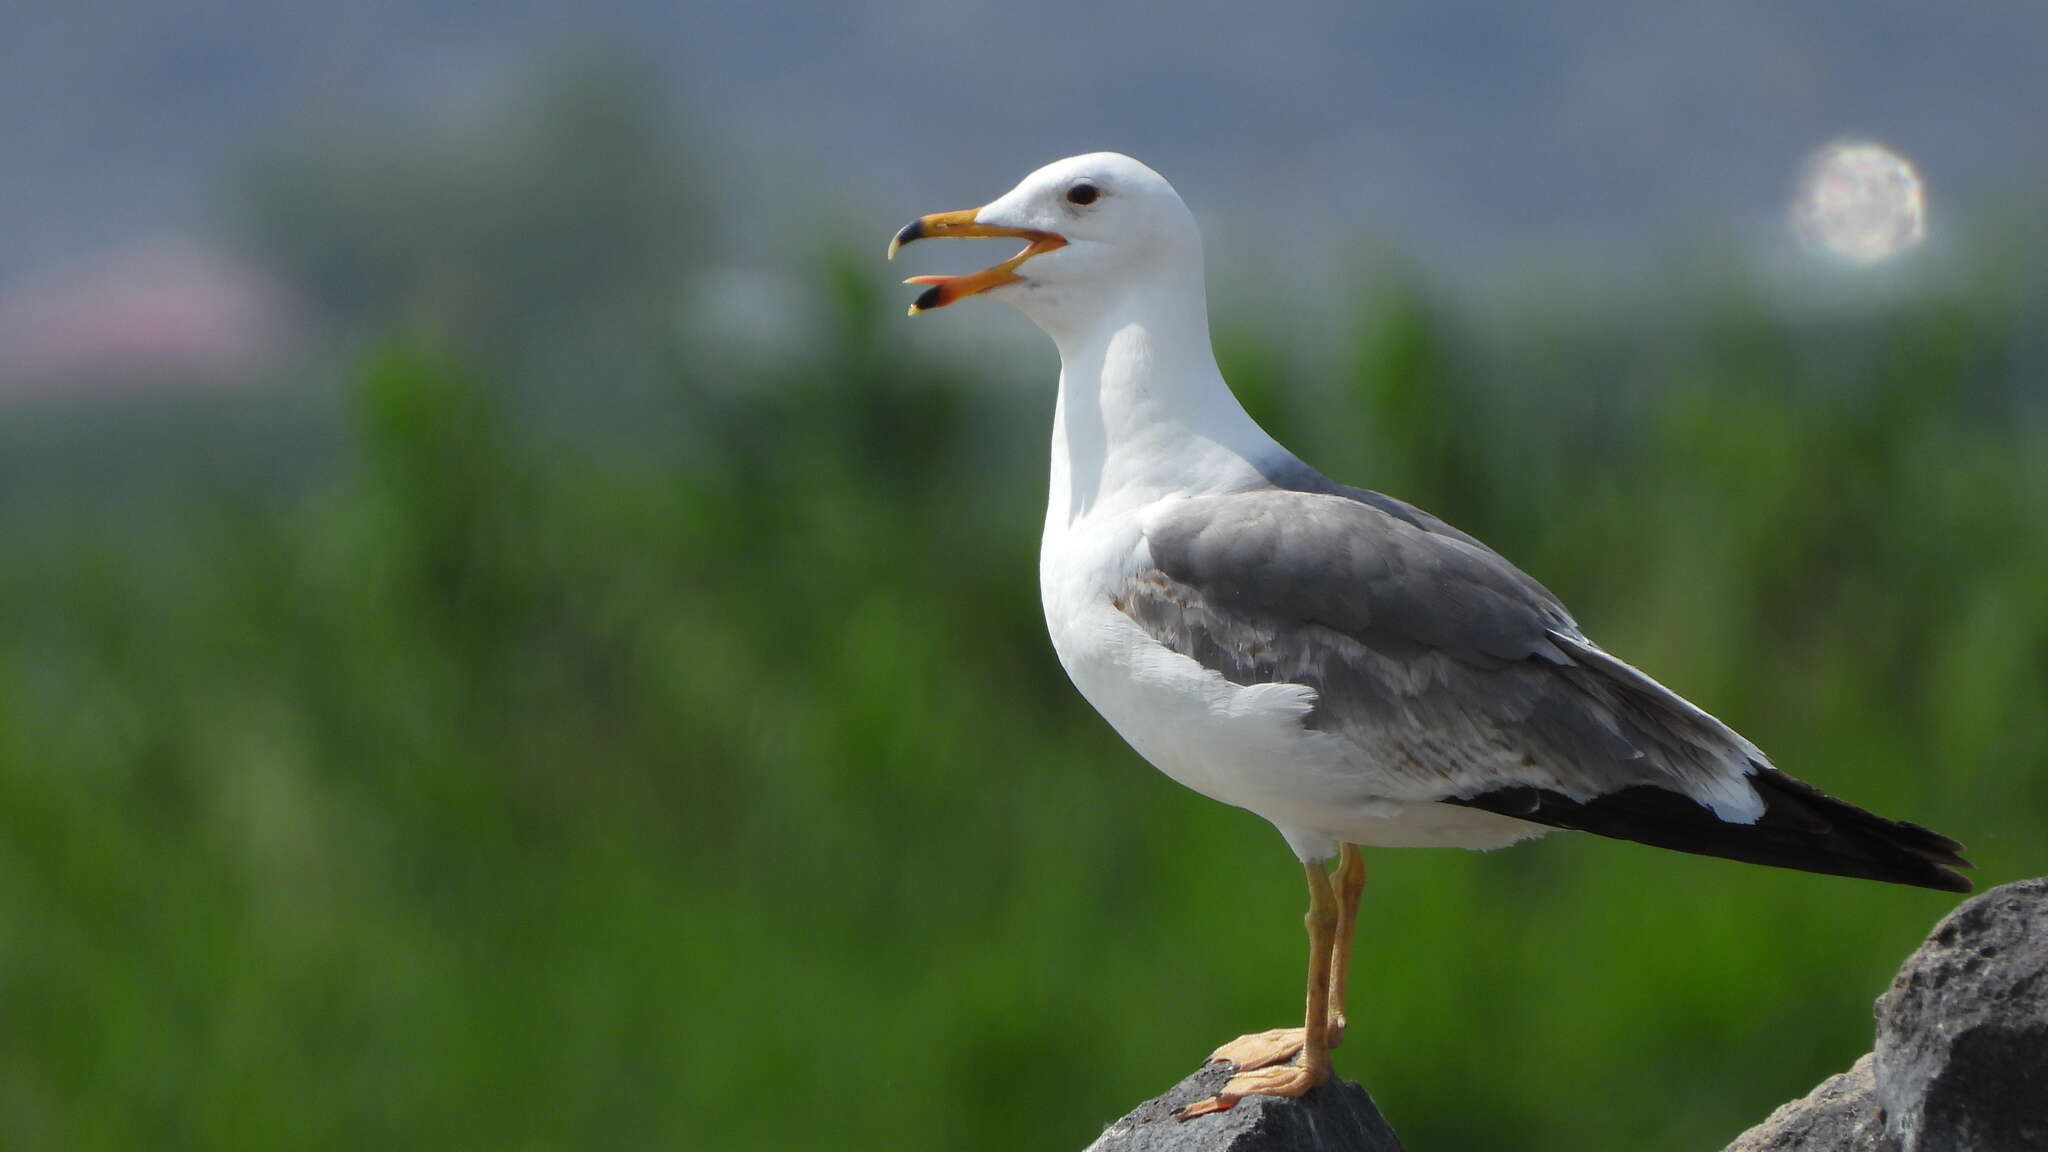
[1118,490,1763,818]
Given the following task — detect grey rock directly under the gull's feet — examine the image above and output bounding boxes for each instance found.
[1087,1064,1403,1152]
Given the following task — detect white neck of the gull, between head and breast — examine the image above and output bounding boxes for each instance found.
[1032,273,1284,537]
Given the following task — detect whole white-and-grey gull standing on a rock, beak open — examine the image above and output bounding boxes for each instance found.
[889,152,1970,1119]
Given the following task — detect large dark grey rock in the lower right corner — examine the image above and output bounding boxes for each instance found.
[1876,877,2048,1152]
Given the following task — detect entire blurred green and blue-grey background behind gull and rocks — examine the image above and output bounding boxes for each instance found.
[0,0,2048,1152]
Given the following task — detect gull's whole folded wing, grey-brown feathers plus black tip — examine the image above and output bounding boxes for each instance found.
[1114,482,1970,892]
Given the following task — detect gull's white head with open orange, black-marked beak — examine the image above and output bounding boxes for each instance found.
[889,152,1202,330]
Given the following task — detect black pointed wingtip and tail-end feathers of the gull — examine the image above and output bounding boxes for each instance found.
[1448,765,1970,892]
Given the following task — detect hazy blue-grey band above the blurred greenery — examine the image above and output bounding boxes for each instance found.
[0,0,2048,301]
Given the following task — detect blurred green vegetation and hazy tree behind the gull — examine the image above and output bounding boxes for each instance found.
[0,49,2048,1152]
